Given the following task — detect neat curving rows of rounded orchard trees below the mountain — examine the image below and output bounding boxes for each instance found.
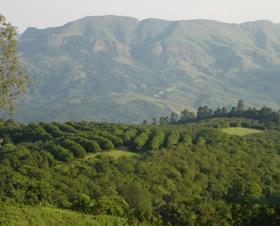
[0,120,197,162]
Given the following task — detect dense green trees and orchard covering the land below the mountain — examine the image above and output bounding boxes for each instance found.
[0,113,280,225]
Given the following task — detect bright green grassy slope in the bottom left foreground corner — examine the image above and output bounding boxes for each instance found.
[0,205,128,226]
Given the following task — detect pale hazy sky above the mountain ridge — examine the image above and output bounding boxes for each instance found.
[0,0,280,31]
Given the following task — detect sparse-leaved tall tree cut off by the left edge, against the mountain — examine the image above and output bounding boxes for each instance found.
[0,14,30,114]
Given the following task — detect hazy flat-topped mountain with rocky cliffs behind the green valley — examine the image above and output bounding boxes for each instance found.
[15,16,280,123]
